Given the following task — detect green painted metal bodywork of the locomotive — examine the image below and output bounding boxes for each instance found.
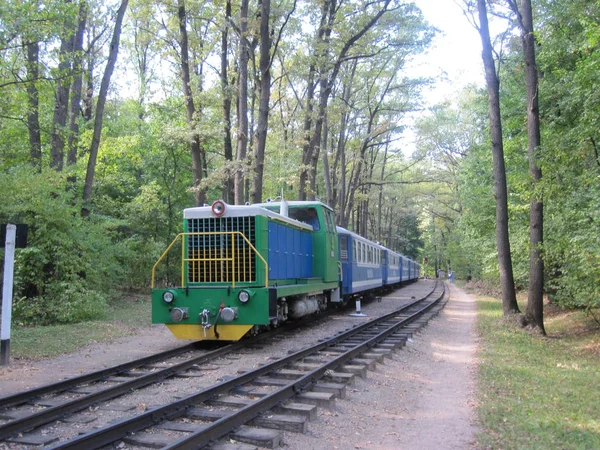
[152,202,340,334]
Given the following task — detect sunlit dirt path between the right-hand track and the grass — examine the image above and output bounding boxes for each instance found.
[286,285,478,450]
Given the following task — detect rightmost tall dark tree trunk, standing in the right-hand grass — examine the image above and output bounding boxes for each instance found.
[515,0,546,335]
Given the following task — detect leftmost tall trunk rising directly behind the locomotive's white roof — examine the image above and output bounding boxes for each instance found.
[177,0,206,206]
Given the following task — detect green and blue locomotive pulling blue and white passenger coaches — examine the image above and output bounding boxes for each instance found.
[151,200,421,341]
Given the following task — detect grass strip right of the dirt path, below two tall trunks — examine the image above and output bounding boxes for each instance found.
[478,297,600,450]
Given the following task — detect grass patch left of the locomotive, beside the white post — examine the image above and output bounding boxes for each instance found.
[10,294,151,359]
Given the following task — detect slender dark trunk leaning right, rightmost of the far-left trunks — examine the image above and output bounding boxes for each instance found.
[81,0,129,217]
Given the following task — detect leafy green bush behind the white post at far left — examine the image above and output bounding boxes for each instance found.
[0,166,120,324]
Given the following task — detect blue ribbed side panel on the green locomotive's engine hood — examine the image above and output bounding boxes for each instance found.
[269,222,313,280]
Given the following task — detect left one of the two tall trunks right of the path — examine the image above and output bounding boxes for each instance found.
[477,0,520,316]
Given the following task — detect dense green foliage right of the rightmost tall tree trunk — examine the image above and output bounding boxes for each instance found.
[539,0,600,308]
